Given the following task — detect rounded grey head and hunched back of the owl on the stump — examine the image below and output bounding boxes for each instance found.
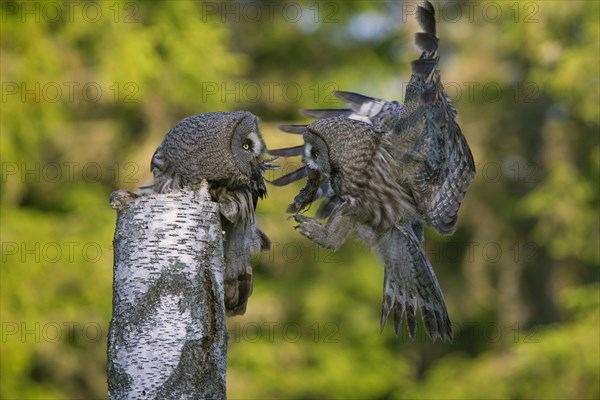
[145,111,266,192]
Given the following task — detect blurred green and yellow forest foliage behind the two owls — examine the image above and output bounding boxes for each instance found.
[0,0,600,399]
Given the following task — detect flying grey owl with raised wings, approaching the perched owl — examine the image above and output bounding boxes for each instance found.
[271,1,475,341]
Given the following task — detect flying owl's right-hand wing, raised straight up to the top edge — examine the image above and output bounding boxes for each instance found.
[391,1,475,233]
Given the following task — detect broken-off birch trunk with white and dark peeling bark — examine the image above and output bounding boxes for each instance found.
[108,185,227,399]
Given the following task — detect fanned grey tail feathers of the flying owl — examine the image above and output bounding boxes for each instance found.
[376,225,452,342]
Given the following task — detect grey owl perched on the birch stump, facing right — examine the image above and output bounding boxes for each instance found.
[142,111,272,315]
